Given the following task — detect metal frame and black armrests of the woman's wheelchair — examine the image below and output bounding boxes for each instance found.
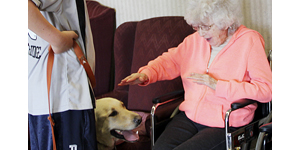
[150,95,272,150]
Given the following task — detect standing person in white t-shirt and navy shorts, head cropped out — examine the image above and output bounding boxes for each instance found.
[28,0,97,150]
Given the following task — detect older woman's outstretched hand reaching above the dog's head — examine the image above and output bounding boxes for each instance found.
[118,73,148,86]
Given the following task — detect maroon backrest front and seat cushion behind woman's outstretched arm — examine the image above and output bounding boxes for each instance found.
[128,17,194,112]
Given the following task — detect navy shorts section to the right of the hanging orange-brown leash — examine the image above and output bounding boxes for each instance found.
[53,109,97,150]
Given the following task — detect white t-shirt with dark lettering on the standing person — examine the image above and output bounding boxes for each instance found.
[28,0,95,115]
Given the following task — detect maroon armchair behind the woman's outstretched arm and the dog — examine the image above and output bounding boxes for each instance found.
[102,17,194,150]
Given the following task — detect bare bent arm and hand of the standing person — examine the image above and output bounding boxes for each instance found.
[28,0,78,53]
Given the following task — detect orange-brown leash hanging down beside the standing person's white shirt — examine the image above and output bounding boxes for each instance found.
[47,41,96,150]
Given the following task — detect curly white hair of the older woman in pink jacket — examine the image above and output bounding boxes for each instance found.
[184,0,241,34]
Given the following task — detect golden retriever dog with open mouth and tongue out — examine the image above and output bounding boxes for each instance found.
[95,97,142,150]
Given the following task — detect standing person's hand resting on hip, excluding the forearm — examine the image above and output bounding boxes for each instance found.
[50,31,78,53]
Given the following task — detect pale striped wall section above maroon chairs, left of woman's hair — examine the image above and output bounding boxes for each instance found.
[97,0,186,26]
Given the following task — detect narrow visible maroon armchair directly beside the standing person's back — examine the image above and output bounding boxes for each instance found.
[86,0,116,97]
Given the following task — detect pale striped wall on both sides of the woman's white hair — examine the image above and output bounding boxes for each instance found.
[96,0,272,51]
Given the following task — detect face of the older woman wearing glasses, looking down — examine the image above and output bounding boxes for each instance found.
[193,24,228,47]
